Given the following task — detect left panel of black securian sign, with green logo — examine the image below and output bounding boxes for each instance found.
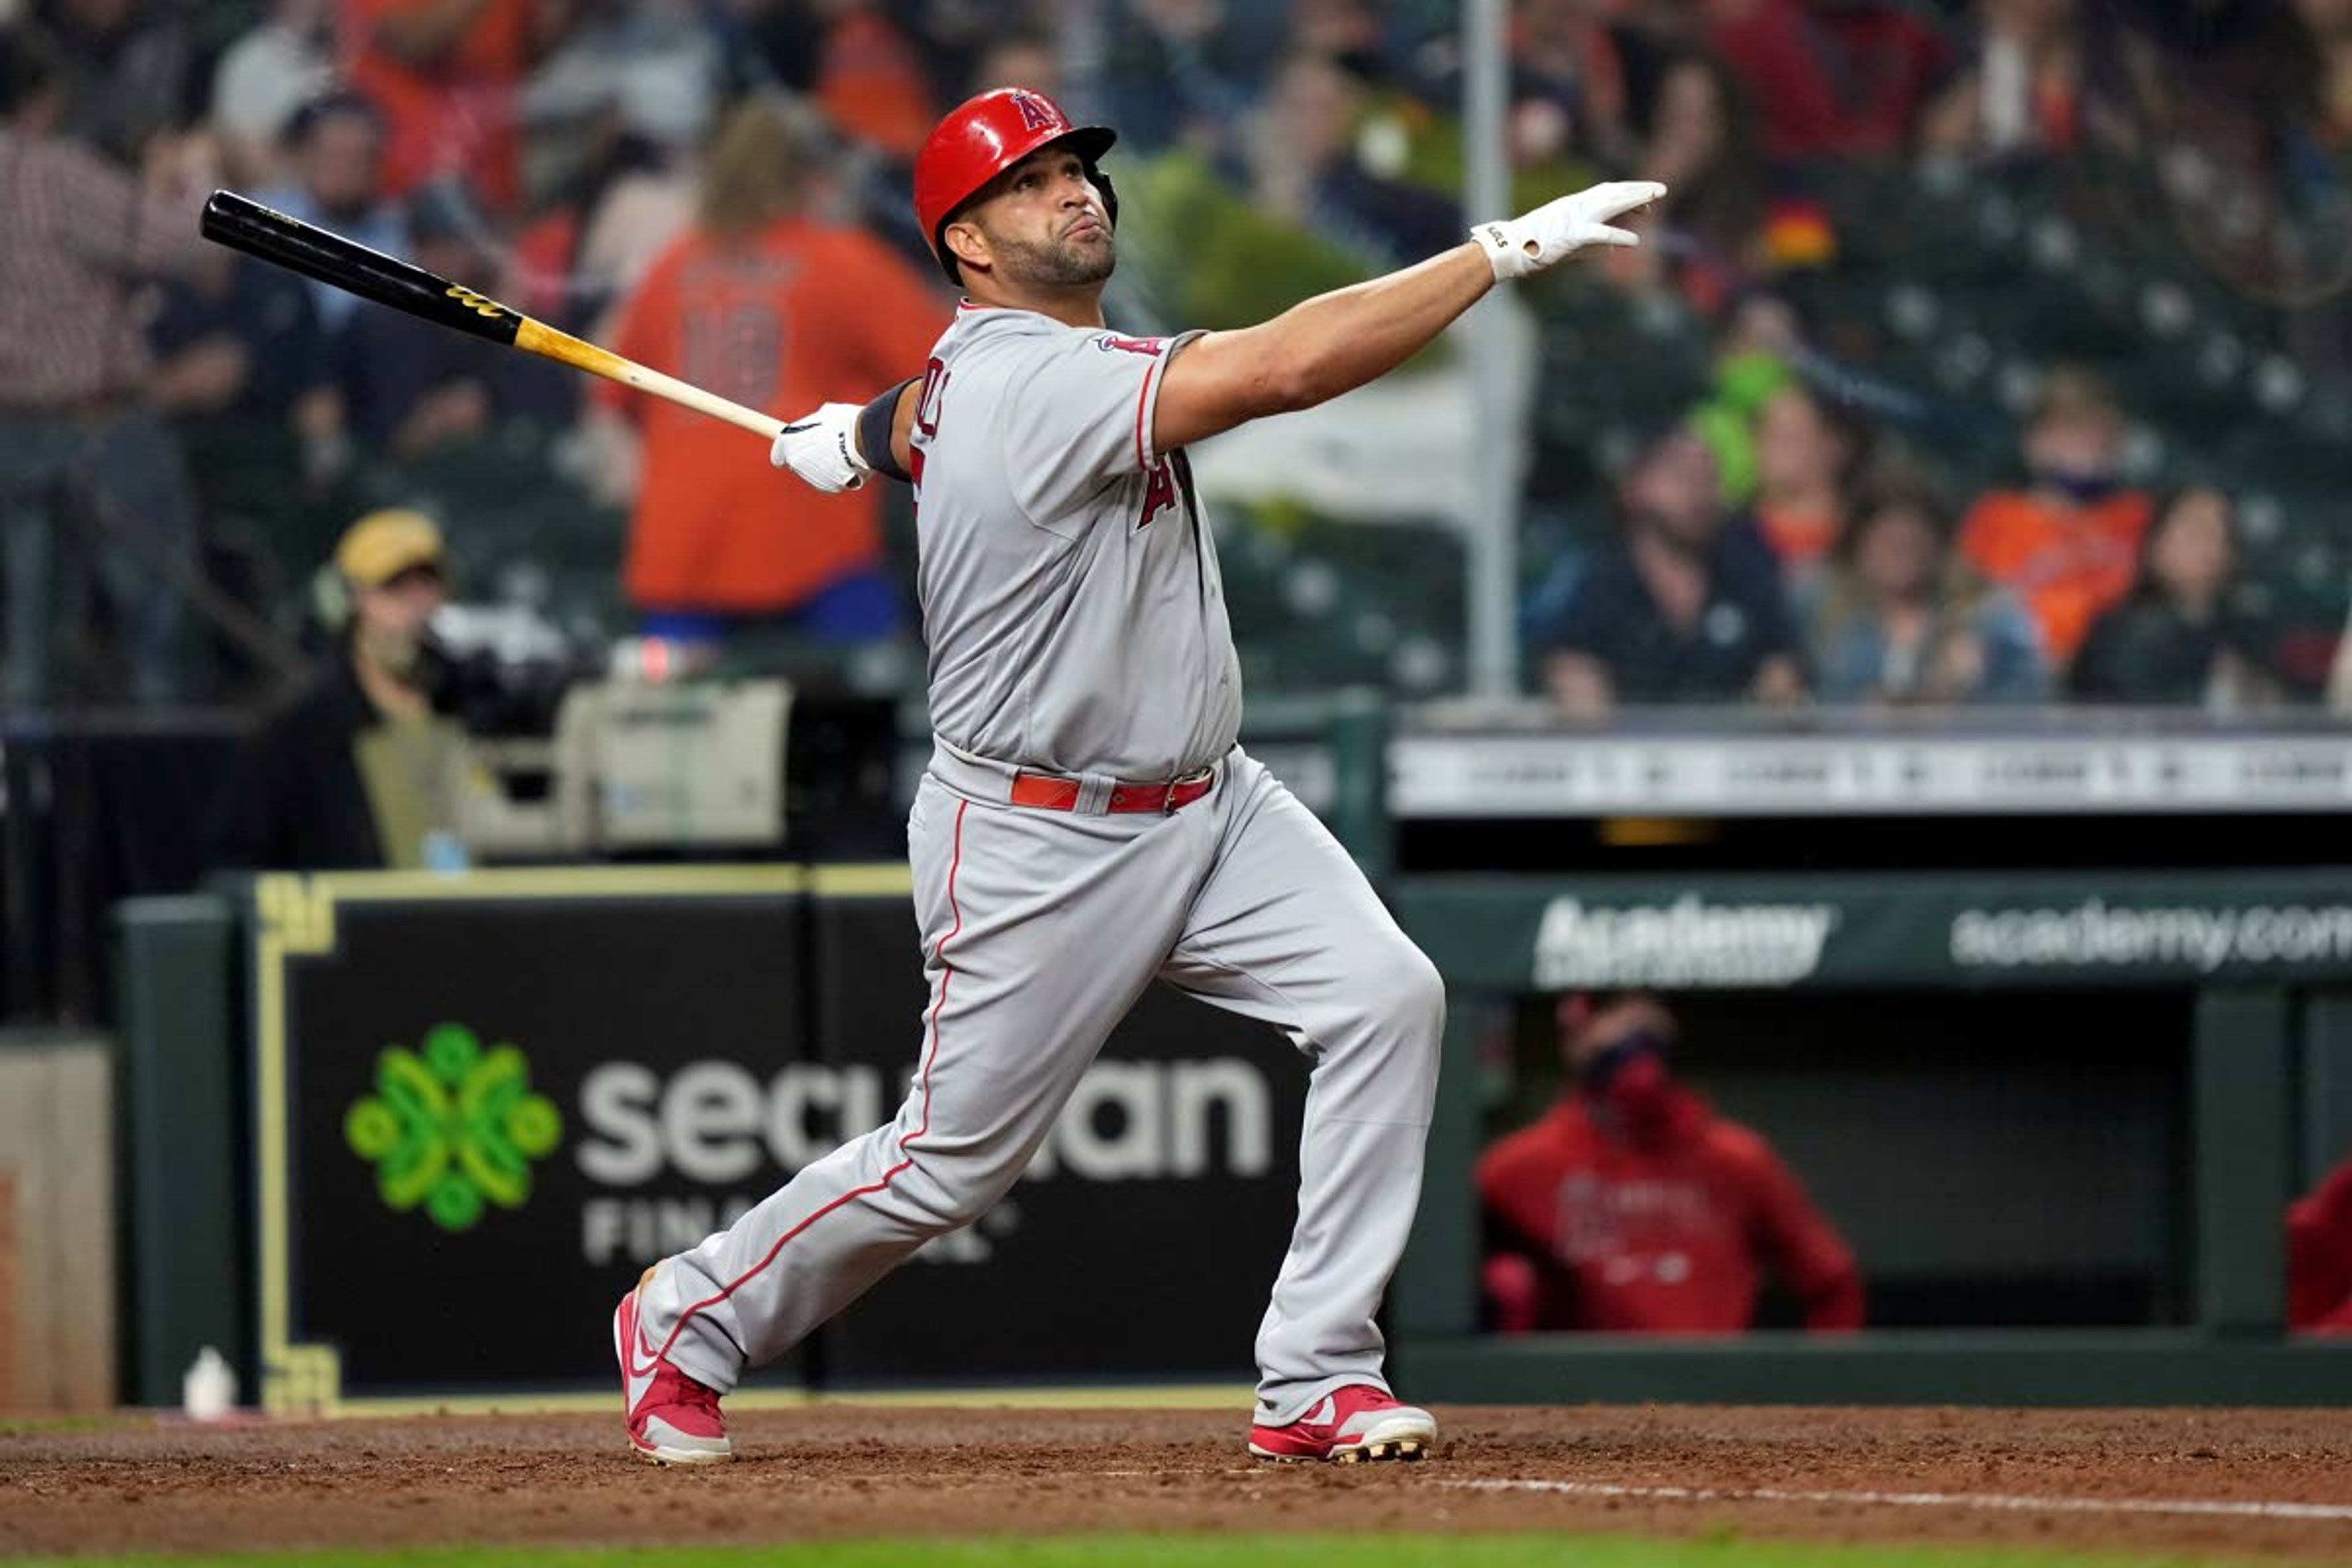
[254,867,831,1408]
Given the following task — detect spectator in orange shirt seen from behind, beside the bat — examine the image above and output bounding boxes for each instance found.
[593,99,948,651]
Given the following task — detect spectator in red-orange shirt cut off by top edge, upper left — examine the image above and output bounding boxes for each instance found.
[339,0,565,211]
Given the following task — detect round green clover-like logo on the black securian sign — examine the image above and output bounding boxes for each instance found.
[344,1023,565,1229]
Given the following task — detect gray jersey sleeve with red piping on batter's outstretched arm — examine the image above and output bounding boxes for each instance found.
[1005,331,1199,527]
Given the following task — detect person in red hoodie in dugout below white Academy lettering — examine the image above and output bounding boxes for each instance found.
[1477,992,1863,1333]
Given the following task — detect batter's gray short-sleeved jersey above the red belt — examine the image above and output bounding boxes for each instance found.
[913,306,1242,778]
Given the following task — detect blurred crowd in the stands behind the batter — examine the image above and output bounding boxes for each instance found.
[0,0,2352,715]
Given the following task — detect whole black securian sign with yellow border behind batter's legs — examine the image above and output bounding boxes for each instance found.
[252,867,1305,1408]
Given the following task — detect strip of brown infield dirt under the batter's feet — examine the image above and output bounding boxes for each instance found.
[0,1406,2352,1563]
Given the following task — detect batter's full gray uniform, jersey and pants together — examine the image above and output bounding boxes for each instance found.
[638,297,1444,1425]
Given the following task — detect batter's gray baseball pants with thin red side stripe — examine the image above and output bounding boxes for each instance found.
[639,748,1444,1425]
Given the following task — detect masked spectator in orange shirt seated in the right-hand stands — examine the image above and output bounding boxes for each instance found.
[1959,367,2152,670]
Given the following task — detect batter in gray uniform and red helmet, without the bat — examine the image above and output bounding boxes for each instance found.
[614,89,1665,1464]
